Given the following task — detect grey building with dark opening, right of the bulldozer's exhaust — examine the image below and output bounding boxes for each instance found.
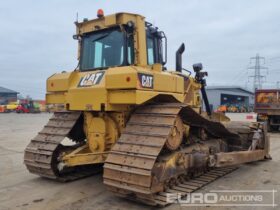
[206,86,254,111]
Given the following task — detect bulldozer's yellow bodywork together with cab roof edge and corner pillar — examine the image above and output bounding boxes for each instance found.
[43,13,203,116]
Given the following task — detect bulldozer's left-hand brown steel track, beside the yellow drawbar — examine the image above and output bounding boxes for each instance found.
[24,112,101,182]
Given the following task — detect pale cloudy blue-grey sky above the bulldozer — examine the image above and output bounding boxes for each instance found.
[0,0,280,99]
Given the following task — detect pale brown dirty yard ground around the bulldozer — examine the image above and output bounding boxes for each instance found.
[0,113,280,210]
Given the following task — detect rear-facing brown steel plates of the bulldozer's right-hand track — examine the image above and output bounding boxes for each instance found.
[103,105,180,205]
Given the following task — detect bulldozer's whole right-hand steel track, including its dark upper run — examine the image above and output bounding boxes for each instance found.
[103,104,241,206]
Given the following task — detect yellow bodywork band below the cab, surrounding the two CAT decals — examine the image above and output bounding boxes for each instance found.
[47,66,187,111]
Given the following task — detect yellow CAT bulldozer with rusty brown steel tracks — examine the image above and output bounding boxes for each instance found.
[24,10,269,206]
